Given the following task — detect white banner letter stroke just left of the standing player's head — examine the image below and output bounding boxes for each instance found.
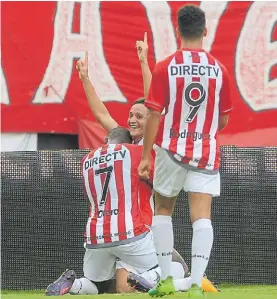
[141,1,177,61]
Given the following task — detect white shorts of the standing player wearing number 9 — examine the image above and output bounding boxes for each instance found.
[153,146,220,197]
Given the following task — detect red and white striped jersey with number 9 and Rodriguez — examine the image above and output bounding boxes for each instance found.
[145,49,232,171]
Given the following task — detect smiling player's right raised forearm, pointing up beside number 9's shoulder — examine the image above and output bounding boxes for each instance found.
[136,32,152,98]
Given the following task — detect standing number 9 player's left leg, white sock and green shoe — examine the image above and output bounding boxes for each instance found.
[148,192,177,296]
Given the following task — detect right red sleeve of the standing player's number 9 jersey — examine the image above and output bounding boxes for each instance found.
[219,65,233,115]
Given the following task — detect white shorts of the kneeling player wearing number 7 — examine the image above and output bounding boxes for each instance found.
[83,232,158,282]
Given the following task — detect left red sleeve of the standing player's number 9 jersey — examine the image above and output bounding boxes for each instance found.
[145,62,169,113]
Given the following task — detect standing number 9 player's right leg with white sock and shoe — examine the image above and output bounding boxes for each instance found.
[188,192,213,297]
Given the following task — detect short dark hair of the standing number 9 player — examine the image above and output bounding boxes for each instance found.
[177,4,206,39]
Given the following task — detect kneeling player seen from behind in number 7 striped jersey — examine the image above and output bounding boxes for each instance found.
[46,127,159,296]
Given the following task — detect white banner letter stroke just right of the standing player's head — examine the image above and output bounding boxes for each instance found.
[200,1,228,52]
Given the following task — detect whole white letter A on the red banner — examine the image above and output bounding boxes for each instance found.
[33,1,127,104]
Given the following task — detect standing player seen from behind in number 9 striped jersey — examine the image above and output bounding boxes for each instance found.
[138,5,232,297]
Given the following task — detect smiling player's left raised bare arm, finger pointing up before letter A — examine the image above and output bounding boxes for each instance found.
[76,52,118,132]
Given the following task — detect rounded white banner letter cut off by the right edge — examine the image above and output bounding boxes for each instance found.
[236,1,277,111]
